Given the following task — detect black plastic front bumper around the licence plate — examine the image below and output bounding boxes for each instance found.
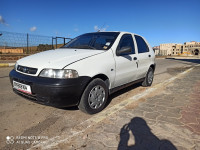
[9,69,91,107]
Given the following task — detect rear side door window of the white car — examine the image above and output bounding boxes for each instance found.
[135,35,149,53]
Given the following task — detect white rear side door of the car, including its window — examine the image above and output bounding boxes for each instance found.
[135,35,152,79]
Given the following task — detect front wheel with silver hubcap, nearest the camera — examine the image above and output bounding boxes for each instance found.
[78,78,108,114]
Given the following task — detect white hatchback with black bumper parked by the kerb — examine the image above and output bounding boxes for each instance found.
[10,32,155,114]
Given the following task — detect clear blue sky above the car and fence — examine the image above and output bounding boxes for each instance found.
[0,0,200,46]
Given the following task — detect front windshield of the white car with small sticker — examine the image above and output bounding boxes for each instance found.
[62,32,119,50]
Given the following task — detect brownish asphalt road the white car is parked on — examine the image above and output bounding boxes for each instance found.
[0,59,200,149]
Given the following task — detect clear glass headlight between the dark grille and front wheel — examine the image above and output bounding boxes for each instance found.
[39,69,78,79]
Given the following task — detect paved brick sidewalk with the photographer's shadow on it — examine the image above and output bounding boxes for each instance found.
[39,67,200,150]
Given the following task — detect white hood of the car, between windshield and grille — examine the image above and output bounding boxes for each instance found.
[17,48,105,70]
